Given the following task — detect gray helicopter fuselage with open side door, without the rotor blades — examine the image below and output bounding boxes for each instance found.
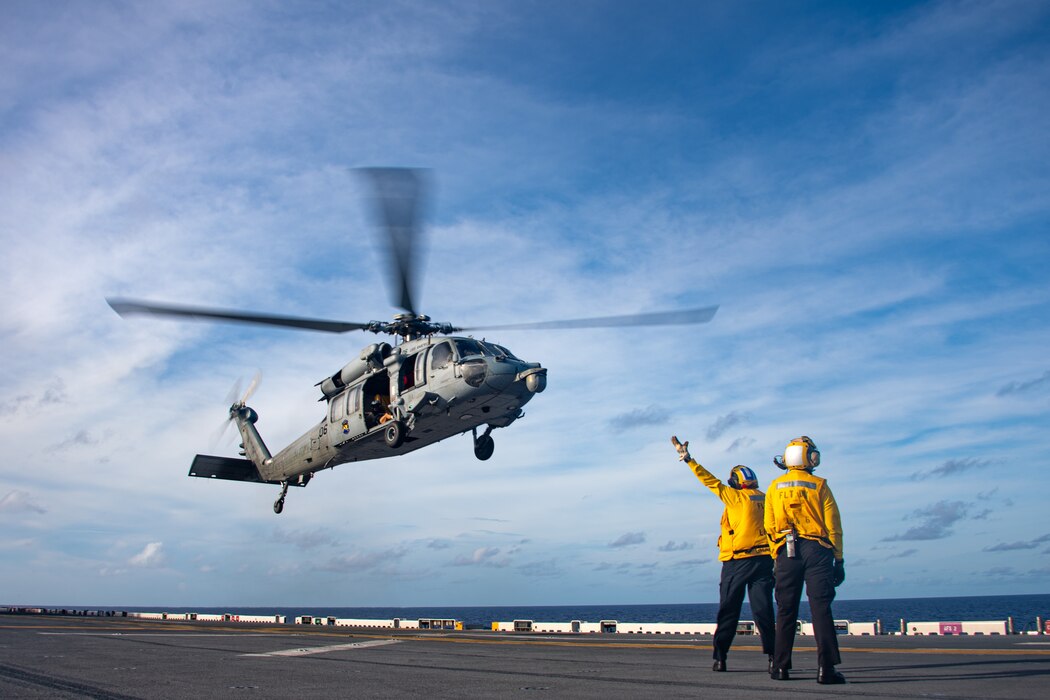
[234,336,547,491]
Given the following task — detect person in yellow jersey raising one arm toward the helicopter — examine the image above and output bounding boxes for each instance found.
[671,438,774,671]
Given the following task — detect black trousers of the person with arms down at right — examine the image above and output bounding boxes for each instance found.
[773,539,842,669]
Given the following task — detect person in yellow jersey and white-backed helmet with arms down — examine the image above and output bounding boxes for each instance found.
[765,436,846,684]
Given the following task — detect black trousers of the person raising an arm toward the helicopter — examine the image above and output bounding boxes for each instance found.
[714,554,774,661]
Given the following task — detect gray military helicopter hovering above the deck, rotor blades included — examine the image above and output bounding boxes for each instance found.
[106,168,718,514]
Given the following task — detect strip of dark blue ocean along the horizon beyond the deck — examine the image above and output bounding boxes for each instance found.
[100,594,1050,632]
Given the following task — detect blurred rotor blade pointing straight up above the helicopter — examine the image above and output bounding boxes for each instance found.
[357,168,425,316]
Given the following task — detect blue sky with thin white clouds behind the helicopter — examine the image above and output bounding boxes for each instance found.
[0,2,1050,607]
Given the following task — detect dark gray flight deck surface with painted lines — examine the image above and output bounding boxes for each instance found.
[0,615,1050,700]
